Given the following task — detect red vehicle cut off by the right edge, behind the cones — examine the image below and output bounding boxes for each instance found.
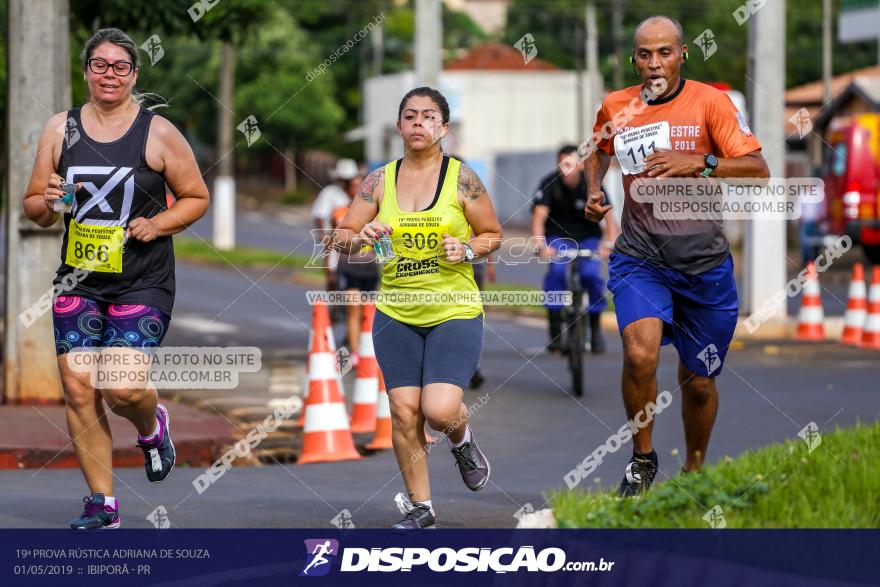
[822,114,880,263]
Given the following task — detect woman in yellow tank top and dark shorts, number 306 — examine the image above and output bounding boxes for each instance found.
[327,87,502,529]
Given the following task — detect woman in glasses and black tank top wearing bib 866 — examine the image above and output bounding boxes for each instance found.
[24,29,209,530]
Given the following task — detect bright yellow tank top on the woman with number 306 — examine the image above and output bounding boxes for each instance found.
[376,157,483,326]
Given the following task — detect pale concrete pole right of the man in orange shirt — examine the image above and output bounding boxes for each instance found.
[743,0,786,334]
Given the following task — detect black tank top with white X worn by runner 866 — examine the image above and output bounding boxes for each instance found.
[54,108,175,316]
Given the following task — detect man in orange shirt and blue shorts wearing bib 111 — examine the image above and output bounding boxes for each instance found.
[586,16,769,497]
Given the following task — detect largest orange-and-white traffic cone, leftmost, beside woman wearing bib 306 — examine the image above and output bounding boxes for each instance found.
[297,320,361,465]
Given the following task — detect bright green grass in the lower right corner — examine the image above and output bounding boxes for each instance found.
[551,423,880,528]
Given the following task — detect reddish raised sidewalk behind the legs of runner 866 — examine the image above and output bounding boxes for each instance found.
[0,400,233,469]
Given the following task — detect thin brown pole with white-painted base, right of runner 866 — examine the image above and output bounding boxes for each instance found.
[211,40,235,251]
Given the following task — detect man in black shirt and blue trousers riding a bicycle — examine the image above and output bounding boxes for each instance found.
[532,145,618,354]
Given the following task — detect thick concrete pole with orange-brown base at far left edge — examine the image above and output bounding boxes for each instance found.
[3,0,71,403]
